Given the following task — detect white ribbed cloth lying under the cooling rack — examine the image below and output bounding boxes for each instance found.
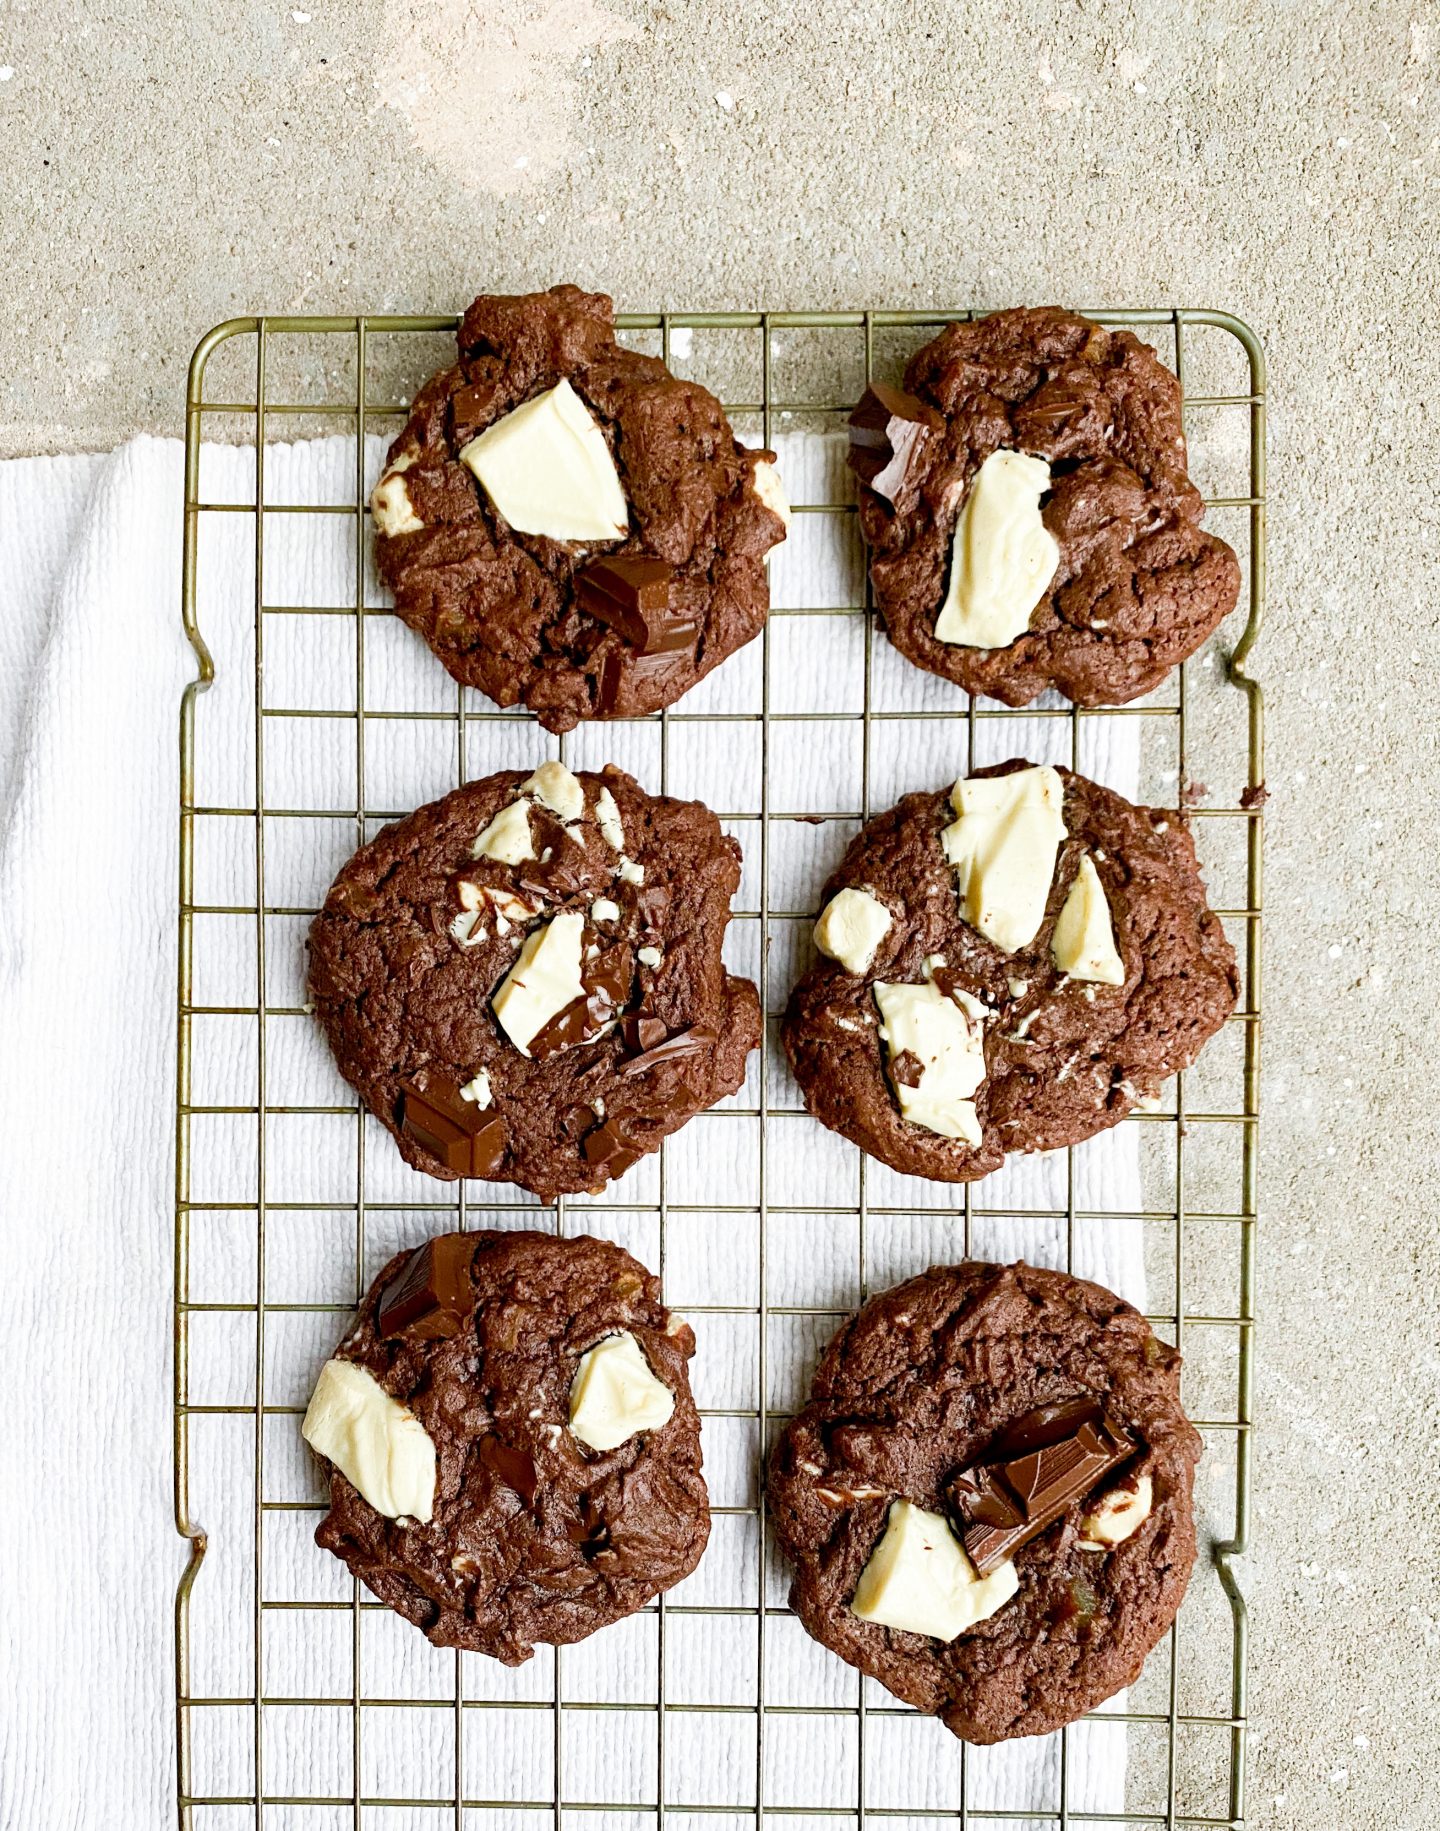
[0,434,1143,1831]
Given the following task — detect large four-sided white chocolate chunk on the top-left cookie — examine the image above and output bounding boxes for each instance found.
[460,381,630,540]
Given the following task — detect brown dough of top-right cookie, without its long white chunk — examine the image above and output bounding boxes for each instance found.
[859,308,1240,705]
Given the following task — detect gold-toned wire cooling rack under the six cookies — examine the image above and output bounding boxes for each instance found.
[174,309,1266,1831]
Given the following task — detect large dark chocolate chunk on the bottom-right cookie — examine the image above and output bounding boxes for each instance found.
[947,1401,1138,1576]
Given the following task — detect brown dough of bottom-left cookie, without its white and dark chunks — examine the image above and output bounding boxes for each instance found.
[315,1232,709,1666]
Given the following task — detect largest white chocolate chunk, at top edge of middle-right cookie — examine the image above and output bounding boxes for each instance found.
[940,764,1064,954]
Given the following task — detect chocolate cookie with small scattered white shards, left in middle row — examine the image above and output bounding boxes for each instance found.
[310,762,760,1199]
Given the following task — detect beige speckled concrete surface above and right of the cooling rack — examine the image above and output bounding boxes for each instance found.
[0,0,1440,1831]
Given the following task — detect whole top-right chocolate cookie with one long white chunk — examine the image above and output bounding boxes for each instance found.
[850,308,1240,705]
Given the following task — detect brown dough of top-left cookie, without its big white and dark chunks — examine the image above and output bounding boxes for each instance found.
[364,286,784,731]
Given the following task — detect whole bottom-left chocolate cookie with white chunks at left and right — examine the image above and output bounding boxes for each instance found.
[302,1232,709,1666]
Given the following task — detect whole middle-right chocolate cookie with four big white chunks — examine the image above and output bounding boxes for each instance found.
[784,762,1238,1183]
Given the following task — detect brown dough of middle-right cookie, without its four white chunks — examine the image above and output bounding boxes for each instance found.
[782,760,1238,1183]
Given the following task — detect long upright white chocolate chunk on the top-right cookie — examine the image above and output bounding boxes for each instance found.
[934,452,1061,648]
